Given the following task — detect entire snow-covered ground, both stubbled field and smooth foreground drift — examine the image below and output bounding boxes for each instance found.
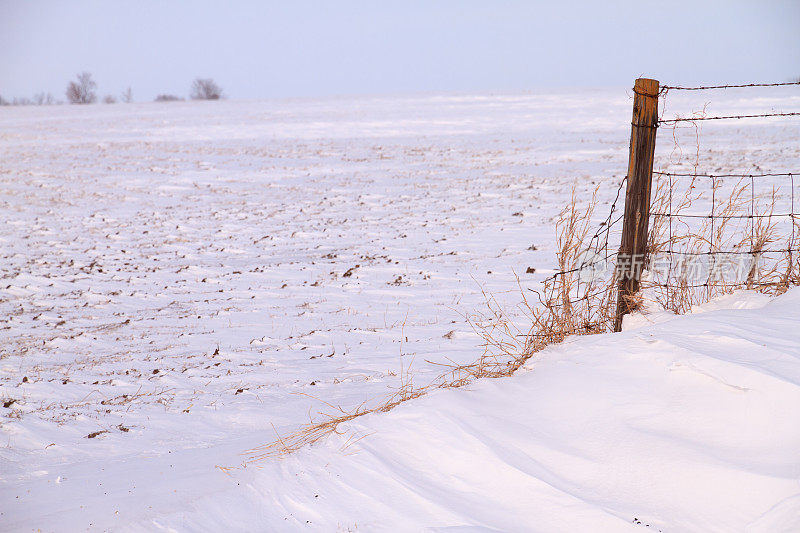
[0,89,800,532]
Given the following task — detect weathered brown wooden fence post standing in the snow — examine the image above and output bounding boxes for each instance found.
[614,78,659,331]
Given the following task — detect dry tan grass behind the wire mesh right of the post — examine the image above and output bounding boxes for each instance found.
[642,177,800,314]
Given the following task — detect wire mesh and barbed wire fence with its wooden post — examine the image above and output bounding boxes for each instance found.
[540,79,800,333]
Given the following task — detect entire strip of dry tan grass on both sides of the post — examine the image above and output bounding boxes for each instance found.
[244,172,800,465]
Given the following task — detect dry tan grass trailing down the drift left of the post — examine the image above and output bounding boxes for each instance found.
[243,187,614,465]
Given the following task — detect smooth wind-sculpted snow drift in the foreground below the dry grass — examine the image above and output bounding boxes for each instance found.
[159,289,800,532]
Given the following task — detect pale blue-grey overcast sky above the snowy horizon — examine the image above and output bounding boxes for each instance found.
[0,0,800,100]
